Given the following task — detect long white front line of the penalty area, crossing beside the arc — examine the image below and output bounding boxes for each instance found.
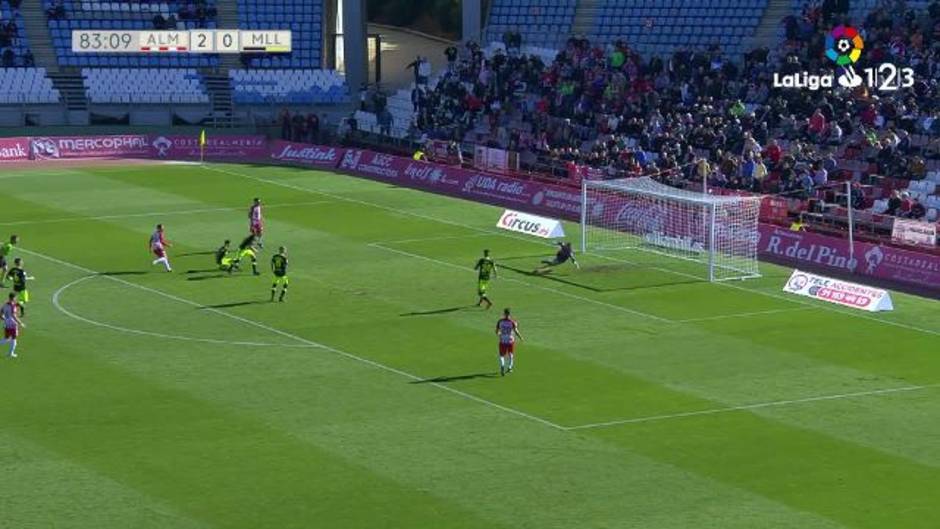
[20,249,565,430]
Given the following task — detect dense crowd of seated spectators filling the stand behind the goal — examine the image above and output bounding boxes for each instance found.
[412,0,940,204]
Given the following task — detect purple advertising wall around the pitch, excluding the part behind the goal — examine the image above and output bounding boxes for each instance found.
[7,134,940,297]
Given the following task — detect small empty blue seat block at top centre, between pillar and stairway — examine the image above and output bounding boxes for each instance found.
[485,0,578,47]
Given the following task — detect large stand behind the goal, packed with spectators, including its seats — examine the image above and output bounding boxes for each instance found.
[355,0,940,233]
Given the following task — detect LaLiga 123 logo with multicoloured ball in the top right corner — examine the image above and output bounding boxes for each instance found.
[774,26,914,92]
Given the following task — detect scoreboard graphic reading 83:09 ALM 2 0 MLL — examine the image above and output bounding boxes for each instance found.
[72,29,291,53]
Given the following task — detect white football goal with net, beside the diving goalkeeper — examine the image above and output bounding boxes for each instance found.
[581,177,761,281]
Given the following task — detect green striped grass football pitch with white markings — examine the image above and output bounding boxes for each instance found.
[0,164,940,529]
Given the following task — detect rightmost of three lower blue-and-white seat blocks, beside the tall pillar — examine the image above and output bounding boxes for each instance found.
[229,69,349,104]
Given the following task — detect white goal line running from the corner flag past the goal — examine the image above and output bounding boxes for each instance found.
[200,165,940,336]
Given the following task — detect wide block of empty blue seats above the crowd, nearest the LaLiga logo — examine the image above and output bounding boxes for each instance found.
[589,0,767,55]
